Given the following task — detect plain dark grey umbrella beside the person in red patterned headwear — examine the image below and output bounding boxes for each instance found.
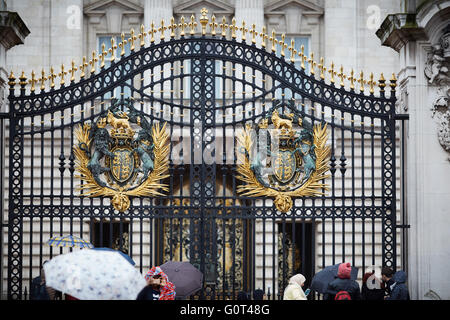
[160,261,203,298]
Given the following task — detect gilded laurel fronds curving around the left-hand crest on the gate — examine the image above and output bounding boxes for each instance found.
[73,123,170,212]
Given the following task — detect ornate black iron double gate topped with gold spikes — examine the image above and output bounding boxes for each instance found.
[8,11,397,299]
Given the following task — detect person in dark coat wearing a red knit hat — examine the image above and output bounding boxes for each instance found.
[325,262,361,300]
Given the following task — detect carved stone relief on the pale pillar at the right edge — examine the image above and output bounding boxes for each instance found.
[425,40,450,161]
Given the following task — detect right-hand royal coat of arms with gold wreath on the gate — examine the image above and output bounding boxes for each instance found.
[237,102,330,213]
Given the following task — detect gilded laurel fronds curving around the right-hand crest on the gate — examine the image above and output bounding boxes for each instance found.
[237,124,331,213]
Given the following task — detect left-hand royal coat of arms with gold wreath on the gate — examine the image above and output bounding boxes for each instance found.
[73,99,169,212]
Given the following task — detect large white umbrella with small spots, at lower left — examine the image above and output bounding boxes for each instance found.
[44,250,146,300]
